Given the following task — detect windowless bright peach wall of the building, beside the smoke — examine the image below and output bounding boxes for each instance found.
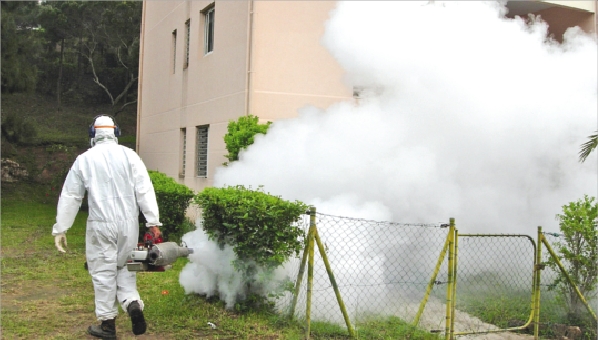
[250,1,352,120]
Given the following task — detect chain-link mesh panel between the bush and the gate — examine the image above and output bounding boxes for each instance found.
[279,213,448,328]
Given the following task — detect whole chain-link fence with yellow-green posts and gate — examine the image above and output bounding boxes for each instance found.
[277,213,597,339]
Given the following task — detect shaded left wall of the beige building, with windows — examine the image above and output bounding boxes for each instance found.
[138,1,254,187]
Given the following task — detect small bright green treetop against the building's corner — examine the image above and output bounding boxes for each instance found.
[224,115,272,165]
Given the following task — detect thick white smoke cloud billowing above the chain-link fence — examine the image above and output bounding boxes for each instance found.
[181,1,598,312]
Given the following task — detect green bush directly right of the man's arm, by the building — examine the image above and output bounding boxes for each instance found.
[139,170,194,241]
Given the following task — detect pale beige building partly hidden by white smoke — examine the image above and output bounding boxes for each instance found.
[137,0,597,191]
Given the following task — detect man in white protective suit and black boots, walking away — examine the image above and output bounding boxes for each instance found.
[52,115,162,339]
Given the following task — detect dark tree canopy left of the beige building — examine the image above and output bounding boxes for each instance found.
[2,1,143,113]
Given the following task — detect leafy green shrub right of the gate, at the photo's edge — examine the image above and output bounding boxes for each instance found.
[548,195,598,323]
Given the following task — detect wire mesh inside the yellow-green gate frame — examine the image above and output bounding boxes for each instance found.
[454,235,536,333]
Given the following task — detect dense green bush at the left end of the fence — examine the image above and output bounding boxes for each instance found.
[195,185,308,278]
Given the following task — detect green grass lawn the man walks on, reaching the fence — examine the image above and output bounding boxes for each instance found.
[1,183,446,340]
